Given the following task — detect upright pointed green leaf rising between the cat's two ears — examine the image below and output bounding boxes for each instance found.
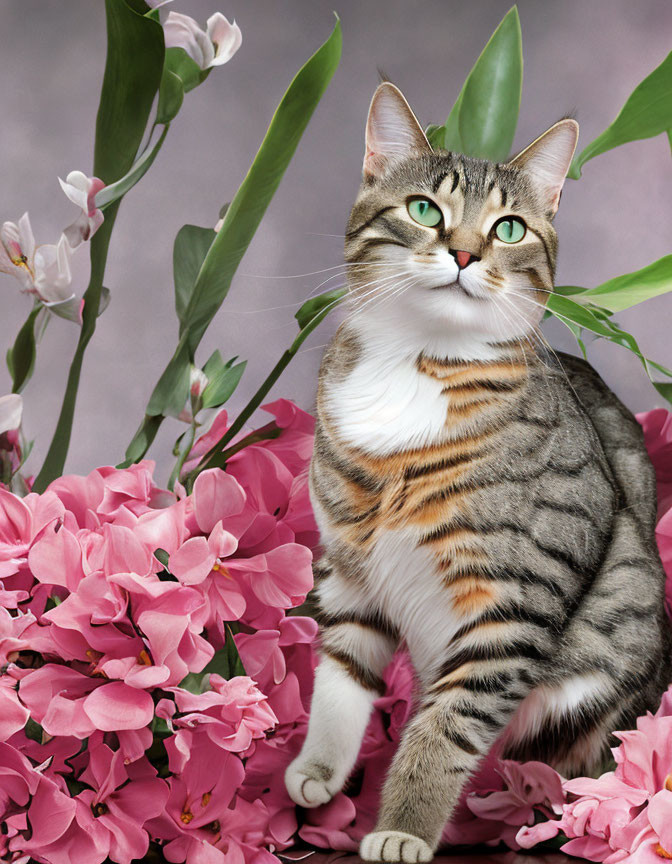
[435,6,523,162]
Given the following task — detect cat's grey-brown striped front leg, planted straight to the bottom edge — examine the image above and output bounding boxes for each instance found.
[359,658,529,864]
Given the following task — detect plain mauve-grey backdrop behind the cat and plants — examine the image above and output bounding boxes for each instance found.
[0,0,672,480]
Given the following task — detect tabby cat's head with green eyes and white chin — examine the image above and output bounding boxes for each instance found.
[345,82,578,352]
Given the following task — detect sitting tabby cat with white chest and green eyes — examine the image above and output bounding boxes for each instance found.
[285,82,671,862]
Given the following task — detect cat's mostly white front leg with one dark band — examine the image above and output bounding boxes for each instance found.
[285,620,396,807]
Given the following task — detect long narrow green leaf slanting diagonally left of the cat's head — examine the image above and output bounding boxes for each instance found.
[180,14,342,356]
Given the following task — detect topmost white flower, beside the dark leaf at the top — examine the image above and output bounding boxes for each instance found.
[163,12,243,69]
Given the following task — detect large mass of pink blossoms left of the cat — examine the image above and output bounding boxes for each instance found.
[0,400,317,864]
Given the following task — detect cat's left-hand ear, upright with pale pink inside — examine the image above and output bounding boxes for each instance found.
[364,81,432,180]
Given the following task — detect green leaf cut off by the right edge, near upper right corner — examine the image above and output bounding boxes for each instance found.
[568,52,672,180]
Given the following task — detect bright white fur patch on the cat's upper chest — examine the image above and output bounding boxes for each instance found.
[326,356,447,455]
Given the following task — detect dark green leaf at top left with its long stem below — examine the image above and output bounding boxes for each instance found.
[33,0,164,492]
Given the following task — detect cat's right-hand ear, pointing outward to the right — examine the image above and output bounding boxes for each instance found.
[509,120,579,213]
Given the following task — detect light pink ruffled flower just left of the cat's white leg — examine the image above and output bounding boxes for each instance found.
[171,675,277,753]
